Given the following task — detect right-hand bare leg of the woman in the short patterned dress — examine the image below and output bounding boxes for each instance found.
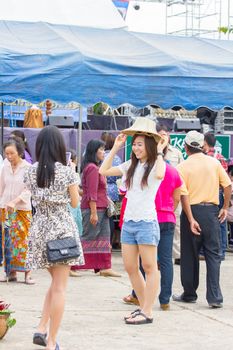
[46,265,70,350]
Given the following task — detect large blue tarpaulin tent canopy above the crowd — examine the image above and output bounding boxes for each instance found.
[0,21,233,110]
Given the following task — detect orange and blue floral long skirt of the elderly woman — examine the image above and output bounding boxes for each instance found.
[0,209,32,274]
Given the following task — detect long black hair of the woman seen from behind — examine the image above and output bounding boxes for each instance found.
[36,125,66,188]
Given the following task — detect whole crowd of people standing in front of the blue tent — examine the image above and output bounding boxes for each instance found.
[0,117,233,350]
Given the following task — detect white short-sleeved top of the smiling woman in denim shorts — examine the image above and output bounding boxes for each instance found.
[117,160,162,221]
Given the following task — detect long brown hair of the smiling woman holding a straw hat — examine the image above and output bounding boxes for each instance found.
[125,134,157,188]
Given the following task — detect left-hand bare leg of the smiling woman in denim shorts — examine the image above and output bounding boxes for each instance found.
[122,244,146,307]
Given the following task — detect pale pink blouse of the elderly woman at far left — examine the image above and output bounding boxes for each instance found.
[0,159,31,211]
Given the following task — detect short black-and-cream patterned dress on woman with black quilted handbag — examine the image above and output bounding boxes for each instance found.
[24,162,84,269]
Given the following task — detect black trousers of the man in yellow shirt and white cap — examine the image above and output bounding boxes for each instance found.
[181,205,223,303]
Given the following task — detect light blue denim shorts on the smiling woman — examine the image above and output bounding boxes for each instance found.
[121,220,160,246]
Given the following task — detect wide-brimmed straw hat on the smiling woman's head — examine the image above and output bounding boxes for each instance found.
[121,117,161,142]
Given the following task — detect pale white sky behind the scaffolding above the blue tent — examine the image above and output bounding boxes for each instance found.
[121,0,233,39]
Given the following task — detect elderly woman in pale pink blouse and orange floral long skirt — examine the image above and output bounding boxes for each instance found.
[0,139,35,284]
